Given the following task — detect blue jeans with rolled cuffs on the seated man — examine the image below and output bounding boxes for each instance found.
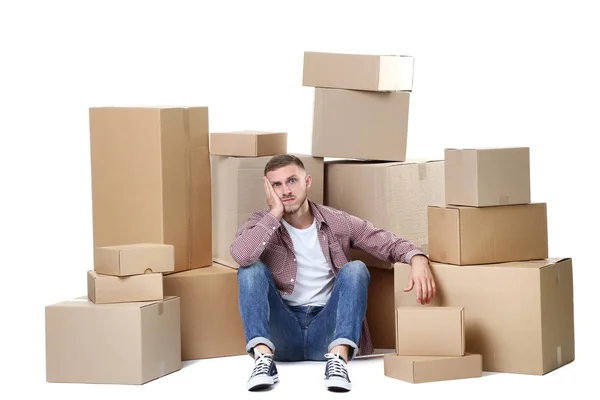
[237,261,370,361]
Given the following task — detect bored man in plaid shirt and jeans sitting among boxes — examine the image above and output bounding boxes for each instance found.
[230,154,436,391]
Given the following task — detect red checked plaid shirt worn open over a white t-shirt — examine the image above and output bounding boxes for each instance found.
[230,200,424,355]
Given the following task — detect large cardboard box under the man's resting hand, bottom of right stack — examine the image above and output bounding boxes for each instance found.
[394,258,575,375]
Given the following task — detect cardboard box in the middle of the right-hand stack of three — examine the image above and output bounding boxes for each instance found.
[428,203,548,265]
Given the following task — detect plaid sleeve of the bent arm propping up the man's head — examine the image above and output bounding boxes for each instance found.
[229,211,281,267]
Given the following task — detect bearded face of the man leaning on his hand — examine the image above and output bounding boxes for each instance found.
[267,164,312,214]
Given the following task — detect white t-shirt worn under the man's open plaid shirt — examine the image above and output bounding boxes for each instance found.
[281,218,335,306]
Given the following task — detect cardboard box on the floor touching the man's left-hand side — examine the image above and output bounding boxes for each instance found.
[163,264,247,361]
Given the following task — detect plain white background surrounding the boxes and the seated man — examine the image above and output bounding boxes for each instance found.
[0,0,600,399]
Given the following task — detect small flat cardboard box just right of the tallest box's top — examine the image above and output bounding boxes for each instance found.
[210,131,287,157]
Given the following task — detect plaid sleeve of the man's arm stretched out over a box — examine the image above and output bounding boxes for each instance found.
[346,213,427,264]
